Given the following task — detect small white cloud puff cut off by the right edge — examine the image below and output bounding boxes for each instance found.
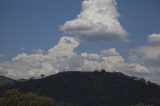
[147,34,160,43]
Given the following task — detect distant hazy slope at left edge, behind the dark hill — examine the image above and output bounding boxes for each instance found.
[0,76,16,86]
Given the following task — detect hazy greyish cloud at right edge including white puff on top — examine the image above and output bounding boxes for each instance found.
[129,34,160,66]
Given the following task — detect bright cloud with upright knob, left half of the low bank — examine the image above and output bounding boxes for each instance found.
[0,36,79,79]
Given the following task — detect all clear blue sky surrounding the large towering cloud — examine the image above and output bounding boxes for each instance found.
[0,0,160,59]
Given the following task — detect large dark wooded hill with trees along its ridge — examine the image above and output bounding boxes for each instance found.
[0,71,160,106]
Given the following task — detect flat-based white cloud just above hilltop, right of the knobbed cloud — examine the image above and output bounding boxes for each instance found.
[81,48,125,71]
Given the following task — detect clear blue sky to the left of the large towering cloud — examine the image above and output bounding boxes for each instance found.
[0,0,80,58]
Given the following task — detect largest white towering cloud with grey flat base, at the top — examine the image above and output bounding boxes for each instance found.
[60,0,128,41]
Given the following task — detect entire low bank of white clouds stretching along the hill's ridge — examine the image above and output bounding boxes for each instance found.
[0,36,160,83]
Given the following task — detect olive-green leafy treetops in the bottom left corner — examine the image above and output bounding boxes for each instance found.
[0,89,57,106]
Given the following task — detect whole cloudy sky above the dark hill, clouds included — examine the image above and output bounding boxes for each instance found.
[0,0,160,83]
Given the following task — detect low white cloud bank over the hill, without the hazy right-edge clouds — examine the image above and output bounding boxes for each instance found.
[0,36,138,79]
